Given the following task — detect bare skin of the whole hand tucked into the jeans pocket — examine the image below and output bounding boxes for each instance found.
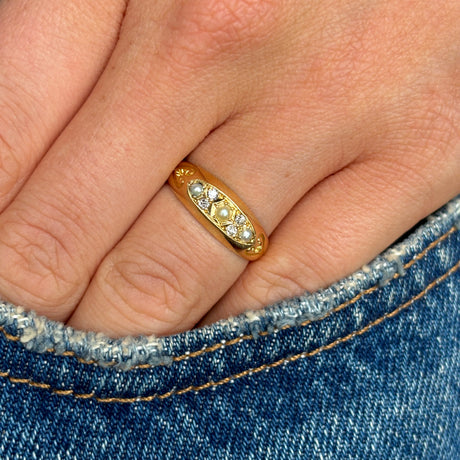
[0,0,460,337]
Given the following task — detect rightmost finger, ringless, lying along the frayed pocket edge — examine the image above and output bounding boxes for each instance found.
[199,145,460,326]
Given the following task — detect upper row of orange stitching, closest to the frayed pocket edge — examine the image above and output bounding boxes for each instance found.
[0,225,457,371]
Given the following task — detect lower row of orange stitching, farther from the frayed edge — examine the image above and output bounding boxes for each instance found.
[0,261,460,403]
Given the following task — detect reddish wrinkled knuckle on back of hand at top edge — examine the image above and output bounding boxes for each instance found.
[165,0,279,63]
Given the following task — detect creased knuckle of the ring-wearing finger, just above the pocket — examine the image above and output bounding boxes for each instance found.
[97,249,194,330]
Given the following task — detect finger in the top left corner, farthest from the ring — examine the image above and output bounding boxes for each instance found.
[0,0,124,211]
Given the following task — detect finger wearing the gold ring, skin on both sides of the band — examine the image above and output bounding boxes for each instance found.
[68,103,358,336]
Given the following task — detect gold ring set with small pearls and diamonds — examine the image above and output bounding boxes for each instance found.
[168,161,268,260]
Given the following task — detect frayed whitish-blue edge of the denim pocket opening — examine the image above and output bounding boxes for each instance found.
[0,196,460,369]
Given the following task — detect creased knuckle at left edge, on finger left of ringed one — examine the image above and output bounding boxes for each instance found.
[0,210,82,311]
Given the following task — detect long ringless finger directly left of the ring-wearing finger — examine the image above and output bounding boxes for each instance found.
[0,2,258,320]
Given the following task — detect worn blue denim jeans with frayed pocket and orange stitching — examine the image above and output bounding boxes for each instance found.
[0,198,460,460]
